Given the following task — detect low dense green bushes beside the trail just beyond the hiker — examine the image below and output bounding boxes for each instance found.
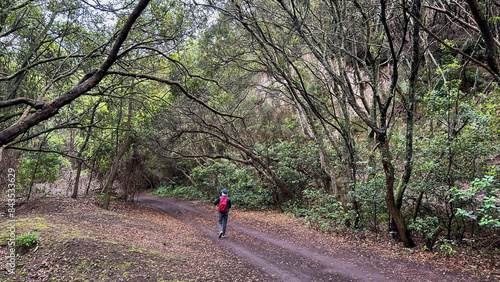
[156,142,322,210]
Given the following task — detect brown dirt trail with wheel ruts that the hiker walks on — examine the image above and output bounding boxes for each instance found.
[138,195,477,281]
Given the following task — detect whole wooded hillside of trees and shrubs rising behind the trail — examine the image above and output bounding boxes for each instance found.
[0,0,500,256]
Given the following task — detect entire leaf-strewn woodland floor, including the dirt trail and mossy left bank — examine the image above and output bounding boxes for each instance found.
[0,195,500,281]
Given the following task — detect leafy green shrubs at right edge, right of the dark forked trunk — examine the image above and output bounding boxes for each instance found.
[414,59,499,238]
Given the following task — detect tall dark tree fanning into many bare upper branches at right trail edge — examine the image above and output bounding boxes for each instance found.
[203,0,414,246]
